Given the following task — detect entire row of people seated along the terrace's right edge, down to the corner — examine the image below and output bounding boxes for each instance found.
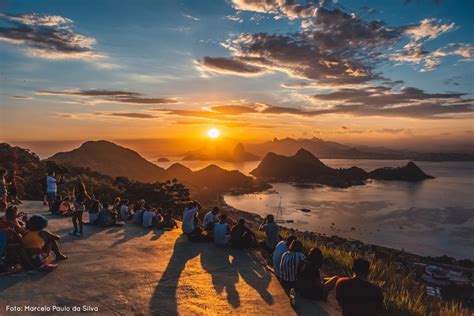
[182,206,383,316]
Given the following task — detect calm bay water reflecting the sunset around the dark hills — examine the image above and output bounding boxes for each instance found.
[215,159,474,260]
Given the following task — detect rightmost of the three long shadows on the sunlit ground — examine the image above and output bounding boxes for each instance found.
[231,249,274,305]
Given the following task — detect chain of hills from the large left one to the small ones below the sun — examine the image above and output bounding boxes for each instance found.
[48,140,267,192]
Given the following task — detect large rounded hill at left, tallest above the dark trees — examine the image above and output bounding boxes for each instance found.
[48,140,165,182]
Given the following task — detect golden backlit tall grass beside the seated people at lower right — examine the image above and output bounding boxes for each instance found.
[274,232,472,316]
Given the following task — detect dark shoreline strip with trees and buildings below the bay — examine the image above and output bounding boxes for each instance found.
[212,192,474,306]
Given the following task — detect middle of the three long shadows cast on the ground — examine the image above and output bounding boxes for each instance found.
[201,244,240,308]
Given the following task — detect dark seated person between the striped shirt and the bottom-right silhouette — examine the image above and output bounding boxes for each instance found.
[296,248,338,301]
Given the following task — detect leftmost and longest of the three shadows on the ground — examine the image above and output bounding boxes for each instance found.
[149,235,200,315]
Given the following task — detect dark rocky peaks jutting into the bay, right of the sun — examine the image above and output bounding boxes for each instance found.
[251,149,433,188]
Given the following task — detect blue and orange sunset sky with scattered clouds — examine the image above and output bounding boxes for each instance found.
[0,0,474,149]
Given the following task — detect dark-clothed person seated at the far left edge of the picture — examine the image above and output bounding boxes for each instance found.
[0,206,33,270]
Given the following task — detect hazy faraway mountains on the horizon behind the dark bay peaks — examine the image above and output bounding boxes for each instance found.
[245,137,474,161]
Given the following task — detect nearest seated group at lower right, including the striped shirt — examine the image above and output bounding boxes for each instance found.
[260,215,383,316]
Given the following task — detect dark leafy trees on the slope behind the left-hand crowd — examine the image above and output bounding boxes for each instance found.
[0,144,190,211]
